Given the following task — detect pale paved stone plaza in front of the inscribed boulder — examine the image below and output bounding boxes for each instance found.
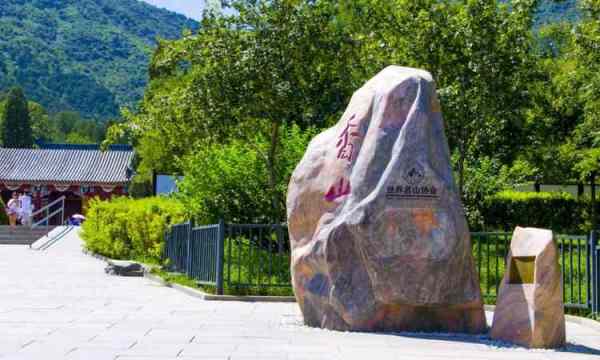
[0,232,600,360]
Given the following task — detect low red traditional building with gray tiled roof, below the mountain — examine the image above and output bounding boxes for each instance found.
[0,144,134,222]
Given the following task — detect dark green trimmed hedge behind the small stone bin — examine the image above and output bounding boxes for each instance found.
[482,191,591,234]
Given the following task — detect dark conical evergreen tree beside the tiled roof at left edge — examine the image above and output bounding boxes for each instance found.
[0,88,33,148]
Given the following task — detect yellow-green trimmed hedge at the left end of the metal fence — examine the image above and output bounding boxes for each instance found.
[81,197,185,262]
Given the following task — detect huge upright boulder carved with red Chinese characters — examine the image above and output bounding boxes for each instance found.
[287,66,486,333]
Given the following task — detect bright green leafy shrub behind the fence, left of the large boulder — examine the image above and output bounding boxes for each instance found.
[176,126,317,224]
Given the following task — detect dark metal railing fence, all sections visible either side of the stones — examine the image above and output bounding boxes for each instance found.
[165,222,600,313]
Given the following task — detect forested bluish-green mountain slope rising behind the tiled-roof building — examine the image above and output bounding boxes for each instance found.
[0,0,198,118]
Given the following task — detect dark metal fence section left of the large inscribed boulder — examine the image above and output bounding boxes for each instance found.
[164,222,291,294]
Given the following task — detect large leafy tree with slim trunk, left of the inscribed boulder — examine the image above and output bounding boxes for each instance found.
[111,0,360,221]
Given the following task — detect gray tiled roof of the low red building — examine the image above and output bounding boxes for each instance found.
[0,146,133,185]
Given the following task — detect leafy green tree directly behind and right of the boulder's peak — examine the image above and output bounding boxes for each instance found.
[343,0,537,194]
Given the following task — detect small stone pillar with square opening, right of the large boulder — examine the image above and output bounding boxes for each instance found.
[491,227,565,348]
